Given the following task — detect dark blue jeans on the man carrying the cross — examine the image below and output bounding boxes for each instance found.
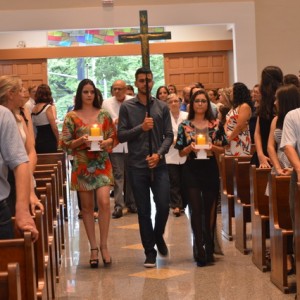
[129,165,170,255]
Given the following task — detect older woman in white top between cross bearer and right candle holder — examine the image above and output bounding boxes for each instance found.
[165,94,188,217]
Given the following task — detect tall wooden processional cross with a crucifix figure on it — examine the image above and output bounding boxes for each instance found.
[119,10,171,70]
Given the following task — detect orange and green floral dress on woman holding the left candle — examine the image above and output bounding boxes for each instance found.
[61,109,116,191]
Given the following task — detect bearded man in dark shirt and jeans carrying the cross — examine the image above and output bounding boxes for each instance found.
[118,68,174,268]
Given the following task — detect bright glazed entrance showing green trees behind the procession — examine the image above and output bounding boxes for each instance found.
[48,55,164,127]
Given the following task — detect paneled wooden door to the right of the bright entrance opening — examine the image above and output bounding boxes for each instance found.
[164,51,229,94]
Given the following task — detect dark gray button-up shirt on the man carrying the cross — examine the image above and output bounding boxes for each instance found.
[118,97,174,168]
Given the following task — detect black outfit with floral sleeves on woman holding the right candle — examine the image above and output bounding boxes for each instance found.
[175,120,220,264]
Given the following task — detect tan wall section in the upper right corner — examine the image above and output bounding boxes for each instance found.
[255,0,300,75]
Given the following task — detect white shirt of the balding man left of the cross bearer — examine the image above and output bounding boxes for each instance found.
[102,95,133,153]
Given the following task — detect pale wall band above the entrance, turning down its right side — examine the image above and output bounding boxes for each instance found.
[0,2,257,86]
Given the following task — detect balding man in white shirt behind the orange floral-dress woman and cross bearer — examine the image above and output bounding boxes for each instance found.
[102,80,136,218]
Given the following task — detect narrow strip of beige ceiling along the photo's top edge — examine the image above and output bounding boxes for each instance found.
[0,0,250,11]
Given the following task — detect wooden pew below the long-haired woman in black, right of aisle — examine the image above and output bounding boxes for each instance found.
[250,165,271,272]
